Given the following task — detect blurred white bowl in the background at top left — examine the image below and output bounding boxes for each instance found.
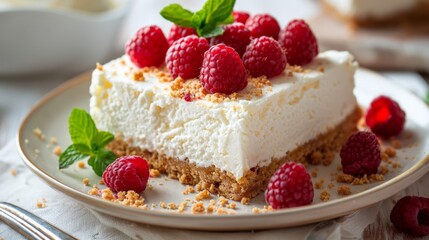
[0,0,132,76]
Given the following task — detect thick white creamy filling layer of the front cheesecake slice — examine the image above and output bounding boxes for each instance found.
[90,51,357,179]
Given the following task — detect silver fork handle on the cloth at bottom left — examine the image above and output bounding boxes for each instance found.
[0,202,76,240]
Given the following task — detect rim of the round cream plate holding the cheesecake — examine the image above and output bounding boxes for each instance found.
[16,68,429,231]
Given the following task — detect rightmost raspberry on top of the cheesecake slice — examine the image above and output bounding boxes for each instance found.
[279,20,319,66]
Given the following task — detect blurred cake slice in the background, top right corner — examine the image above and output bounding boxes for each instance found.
[322,0,429,27]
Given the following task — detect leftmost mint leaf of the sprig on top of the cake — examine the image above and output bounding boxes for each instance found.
[160,4,194,27]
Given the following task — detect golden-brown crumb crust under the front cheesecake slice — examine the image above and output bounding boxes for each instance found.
[108,107,362,201]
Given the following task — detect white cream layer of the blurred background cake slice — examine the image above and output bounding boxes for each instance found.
[325,0,429,19]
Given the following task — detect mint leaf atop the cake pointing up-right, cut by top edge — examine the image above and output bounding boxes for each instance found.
[203,0,235,23]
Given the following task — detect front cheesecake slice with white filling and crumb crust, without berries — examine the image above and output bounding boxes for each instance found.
[90,51,361,200]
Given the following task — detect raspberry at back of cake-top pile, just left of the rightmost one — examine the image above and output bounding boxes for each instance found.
[245,14,280,40]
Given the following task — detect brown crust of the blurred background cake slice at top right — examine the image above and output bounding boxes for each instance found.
[322,0,429,28]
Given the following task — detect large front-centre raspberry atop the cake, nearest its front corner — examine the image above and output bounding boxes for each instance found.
[200,44,247,94]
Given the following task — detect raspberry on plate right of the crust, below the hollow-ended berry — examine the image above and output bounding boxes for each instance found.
[340,131,381,176]
